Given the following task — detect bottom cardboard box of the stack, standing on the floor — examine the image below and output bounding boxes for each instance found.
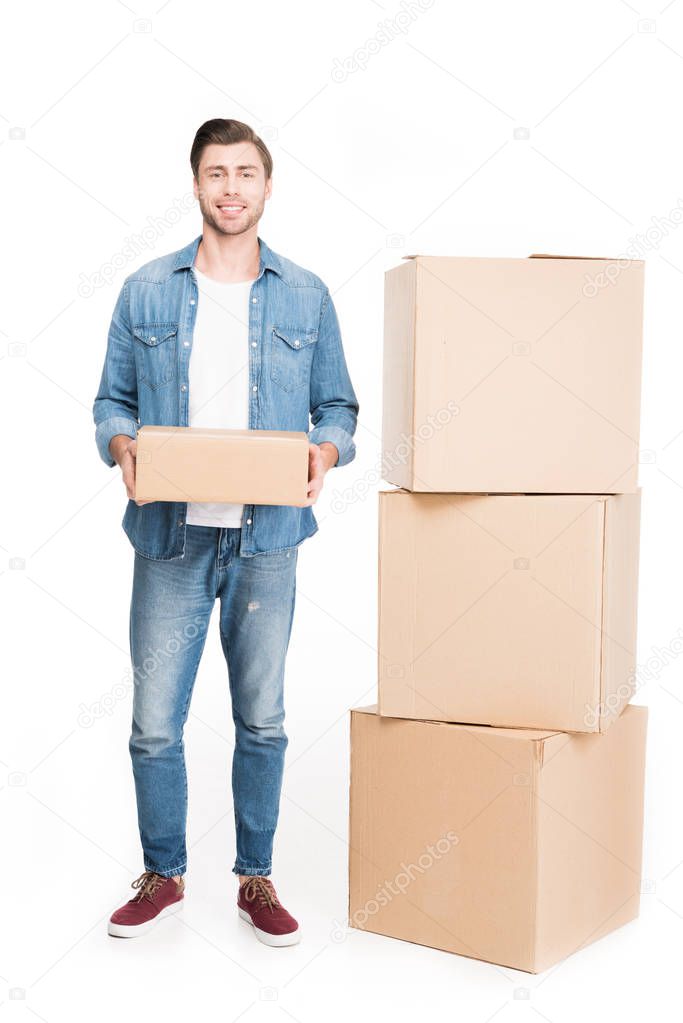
[349,705,647,973]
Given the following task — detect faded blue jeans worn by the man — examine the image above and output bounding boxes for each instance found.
[129,525,299,877]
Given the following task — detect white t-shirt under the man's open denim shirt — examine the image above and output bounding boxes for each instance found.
[186,267,253,528]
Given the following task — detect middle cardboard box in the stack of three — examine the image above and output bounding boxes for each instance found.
[377,490,640,731]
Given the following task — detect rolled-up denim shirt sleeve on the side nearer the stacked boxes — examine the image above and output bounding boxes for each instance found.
[308,290,360,465]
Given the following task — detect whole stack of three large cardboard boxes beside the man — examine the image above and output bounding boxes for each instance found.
[349,256,647,973]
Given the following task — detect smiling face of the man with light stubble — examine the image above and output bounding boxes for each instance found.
[193,142,272,234]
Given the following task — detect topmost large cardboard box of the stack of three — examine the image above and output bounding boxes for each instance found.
[382,256,643,494]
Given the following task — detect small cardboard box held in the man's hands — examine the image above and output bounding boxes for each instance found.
[135,426,309,507]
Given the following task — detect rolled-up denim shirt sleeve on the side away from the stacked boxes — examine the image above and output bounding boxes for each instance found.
[93,281,139,466]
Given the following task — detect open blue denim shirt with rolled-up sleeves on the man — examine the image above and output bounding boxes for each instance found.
[93,235,359,561]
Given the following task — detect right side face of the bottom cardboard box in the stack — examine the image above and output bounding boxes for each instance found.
[536,705,647,970]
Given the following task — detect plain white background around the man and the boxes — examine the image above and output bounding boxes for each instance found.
[0,0,683,1023]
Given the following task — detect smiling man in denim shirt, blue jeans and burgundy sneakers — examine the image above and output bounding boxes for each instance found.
[93,119,359,945]
